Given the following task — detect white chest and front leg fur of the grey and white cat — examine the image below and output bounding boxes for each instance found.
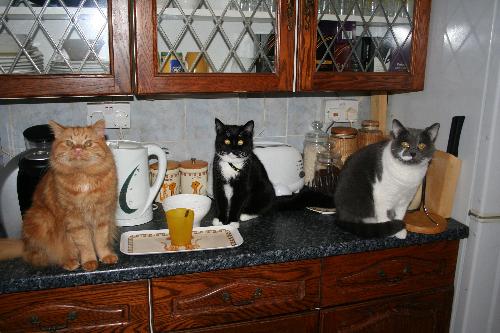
[373,145,428,222]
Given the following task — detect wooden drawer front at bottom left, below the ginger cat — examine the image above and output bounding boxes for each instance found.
[0,281,149,333]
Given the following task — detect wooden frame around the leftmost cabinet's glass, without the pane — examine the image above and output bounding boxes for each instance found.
[0,0,132,98]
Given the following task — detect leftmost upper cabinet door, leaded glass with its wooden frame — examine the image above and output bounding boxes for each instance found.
[0,0,131,97]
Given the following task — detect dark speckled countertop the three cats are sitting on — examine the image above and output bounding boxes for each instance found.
[0,205,469,293]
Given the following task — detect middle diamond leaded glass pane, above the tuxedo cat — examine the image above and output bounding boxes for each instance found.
[156,0,277,73]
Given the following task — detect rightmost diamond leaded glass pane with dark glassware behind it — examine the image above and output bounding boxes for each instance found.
[316,0,414,72]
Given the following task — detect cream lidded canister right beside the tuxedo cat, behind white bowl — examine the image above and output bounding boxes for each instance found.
[179,158,208,195]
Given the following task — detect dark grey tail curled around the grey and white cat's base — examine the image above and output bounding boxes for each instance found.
[335,219,405,238]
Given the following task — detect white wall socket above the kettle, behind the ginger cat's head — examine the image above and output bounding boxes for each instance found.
[87,102,130,128]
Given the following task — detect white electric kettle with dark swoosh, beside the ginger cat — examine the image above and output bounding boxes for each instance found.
[107,140,167,227]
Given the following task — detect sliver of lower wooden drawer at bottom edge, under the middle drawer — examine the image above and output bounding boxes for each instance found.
[182,311,319,333]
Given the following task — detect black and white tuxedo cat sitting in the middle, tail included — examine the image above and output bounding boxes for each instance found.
[212,119,333,227]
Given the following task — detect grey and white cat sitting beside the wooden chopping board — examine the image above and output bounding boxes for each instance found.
[335,119,439,239]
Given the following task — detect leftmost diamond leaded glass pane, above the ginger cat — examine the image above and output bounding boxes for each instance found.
[0,0,110,74]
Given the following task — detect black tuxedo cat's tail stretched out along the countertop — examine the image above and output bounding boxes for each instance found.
[273,188,335,210]
